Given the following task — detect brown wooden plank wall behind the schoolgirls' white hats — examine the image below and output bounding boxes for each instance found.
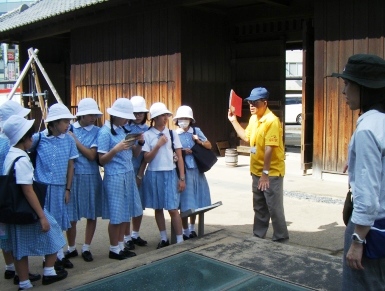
[71,8,181,126]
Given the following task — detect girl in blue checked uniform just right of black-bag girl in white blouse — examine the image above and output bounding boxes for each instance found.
[32,103,79,269]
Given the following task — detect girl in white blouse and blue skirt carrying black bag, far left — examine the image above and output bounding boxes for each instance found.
[3,115,67,290]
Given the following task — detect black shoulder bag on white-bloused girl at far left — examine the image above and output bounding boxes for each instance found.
[0,156,47,224]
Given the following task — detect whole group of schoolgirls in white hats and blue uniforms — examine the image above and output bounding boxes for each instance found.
[0,96,211,290]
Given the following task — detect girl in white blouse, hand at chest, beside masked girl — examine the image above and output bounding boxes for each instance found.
[142,102,186,249]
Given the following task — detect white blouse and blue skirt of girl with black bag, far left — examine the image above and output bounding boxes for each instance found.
[3,147,65,260]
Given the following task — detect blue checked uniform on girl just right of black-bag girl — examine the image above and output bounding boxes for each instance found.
[32,130,79,230]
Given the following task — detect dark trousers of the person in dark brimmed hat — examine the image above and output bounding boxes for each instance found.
[342,220,385,291]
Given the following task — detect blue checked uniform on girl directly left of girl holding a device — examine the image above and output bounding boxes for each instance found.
[67,122,103,221]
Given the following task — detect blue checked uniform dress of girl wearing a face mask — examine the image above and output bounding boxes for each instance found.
[176,127,211,212]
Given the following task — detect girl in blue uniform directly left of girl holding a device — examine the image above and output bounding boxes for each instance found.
[65,98,102,262]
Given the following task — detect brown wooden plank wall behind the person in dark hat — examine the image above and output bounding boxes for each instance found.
[313,0,385,177]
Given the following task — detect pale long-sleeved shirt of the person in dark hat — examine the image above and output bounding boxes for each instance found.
[348,110,385,226]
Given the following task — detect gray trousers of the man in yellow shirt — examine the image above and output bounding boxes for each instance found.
[251,174,289,240]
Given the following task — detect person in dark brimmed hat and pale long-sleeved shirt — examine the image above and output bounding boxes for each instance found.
[332,54,385,290]
